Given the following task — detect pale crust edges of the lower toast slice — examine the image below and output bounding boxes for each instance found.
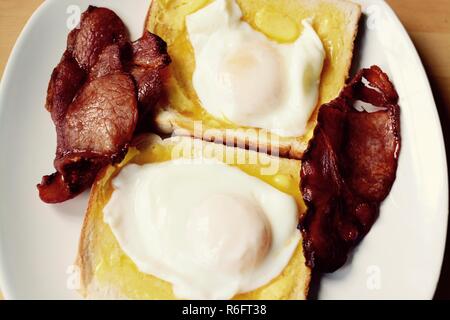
[76,135,311,300]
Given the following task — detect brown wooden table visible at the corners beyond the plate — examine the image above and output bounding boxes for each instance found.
[0,0,450,299]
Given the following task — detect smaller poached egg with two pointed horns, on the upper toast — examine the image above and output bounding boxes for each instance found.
[186,0,325,137]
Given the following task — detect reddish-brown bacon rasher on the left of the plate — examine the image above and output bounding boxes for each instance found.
[38,6,170,203]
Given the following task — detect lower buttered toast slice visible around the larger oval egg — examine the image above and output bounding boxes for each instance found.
[77,135,311,300]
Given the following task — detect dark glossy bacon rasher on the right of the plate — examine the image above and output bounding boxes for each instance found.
[299,66,400,272]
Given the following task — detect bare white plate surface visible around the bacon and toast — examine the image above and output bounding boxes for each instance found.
[0,0,448,299]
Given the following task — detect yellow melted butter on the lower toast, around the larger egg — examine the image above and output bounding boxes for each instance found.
[88,138,309,299]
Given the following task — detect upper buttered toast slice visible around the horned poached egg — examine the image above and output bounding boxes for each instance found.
[146,0,361,159]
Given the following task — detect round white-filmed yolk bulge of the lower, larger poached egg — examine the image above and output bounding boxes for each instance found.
[187,194,272,274]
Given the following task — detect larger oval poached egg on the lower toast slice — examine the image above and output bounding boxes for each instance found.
[103,159,301,299]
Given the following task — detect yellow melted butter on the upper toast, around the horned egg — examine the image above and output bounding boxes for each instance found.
[147,0,350,142]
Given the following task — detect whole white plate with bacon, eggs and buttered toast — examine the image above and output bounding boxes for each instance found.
[0,0,448,300]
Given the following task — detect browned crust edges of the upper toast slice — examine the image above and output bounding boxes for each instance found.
[146,0,361,159]
